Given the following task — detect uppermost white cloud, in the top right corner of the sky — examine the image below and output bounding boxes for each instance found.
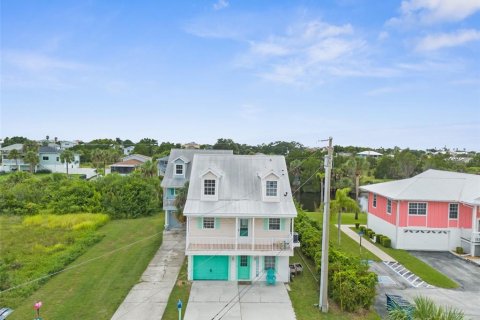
[388,0,480,25]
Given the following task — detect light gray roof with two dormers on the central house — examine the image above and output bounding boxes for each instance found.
[184,155,297,217]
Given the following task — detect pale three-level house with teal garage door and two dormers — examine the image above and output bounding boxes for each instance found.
[184,154,300,282]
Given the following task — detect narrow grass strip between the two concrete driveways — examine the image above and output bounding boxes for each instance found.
[162,258,192,320]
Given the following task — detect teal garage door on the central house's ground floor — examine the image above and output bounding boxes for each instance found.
[193,256,228,280]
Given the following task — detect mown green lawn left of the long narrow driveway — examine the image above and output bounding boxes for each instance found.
[8,214,164,320]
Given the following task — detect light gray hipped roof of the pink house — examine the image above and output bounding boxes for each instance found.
[360,169,480,204]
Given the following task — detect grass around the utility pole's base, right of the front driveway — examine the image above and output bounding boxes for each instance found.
[289,249,380,320]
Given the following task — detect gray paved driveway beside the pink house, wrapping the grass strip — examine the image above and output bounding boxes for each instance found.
[372,252,480,319]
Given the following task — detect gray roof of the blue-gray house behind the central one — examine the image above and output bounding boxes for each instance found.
[161,149,233,188]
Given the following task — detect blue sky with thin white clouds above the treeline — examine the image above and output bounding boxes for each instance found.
[0,0,480,150]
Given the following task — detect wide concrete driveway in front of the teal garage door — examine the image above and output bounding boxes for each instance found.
[184,281,295,320]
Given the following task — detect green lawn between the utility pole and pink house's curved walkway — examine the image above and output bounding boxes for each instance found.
[307,212,380,261]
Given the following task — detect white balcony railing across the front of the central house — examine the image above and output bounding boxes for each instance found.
[187,236,294,251]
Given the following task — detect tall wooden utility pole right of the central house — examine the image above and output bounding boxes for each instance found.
[318,137,333,313]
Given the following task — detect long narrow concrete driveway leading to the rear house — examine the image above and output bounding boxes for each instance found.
[112,231,185,320]
